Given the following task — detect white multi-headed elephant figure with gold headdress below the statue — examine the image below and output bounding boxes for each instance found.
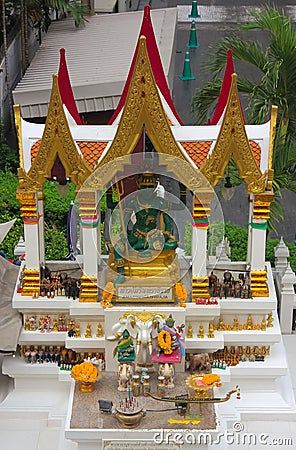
[107,311,166,370]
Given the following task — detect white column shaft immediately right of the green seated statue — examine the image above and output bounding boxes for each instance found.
[192,226,207,277]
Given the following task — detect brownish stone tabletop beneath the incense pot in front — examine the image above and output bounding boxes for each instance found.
[68,372,217,431]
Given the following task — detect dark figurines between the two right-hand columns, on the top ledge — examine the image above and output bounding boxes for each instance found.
[209,270,252,298]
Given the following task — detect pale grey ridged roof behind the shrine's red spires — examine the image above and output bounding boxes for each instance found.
[13,8,177,118]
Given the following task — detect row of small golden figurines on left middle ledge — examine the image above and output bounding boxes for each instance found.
[24,314,104,338]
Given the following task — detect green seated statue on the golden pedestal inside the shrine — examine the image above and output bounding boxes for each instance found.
[107,173,186,284]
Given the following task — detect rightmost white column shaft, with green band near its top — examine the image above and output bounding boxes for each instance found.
[250,219,266,271]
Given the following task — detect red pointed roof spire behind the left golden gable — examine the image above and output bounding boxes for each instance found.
[58,48,82,125]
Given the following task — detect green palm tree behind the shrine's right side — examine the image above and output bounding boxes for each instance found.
[192,6,296,234]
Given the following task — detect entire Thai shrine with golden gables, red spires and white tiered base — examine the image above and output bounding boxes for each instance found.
[3,7,295,450]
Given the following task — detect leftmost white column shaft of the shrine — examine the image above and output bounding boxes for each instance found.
[24,219,40,270]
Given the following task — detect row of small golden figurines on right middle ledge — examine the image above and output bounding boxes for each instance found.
[186,312,274,339]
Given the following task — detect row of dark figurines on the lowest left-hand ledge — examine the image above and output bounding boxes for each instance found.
[20,345,105,370]
